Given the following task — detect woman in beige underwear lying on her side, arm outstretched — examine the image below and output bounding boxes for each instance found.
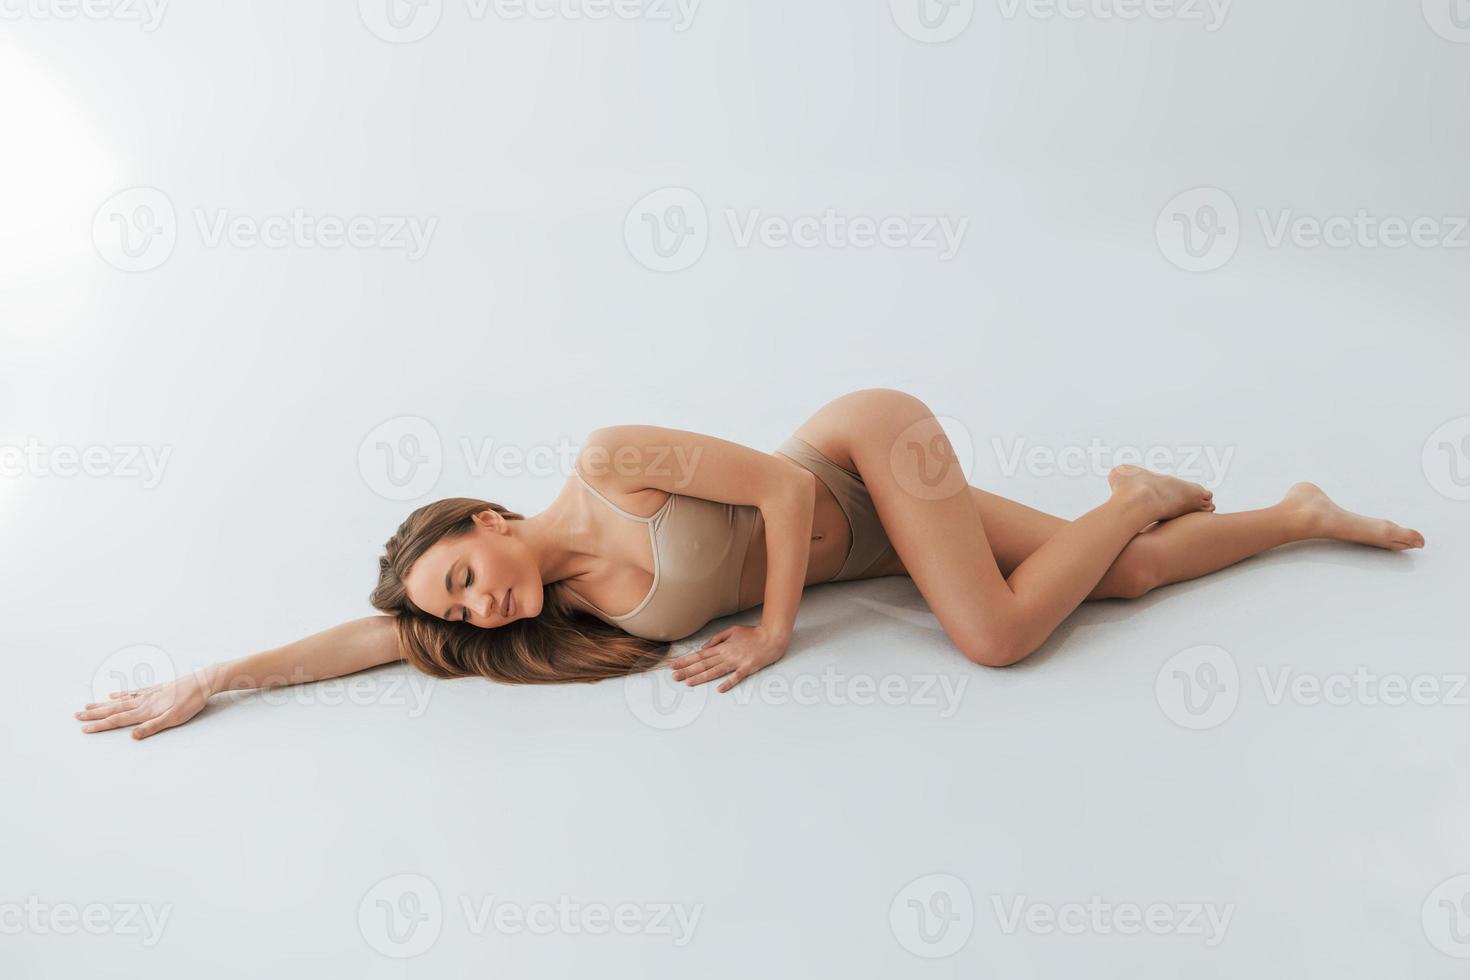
[76,389,1424,738]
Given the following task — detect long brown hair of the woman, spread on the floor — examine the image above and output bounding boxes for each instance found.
[370,497,669,685]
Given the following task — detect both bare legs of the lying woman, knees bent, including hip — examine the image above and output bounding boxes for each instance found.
[798,389,1423,666]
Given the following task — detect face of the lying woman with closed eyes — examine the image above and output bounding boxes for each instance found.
[403,510,542,629]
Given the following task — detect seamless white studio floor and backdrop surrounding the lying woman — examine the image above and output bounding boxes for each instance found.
[0,1,1470,980]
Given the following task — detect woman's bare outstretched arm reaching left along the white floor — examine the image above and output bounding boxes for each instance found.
[76,616,398,739]
